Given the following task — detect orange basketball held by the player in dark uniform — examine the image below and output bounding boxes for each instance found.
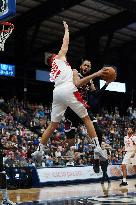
[101,67,117,81]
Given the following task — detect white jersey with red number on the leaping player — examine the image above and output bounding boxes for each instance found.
[50,59,76,88]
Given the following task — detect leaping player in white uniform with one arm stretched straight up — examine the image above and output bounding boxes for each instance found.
[35,22,109,160]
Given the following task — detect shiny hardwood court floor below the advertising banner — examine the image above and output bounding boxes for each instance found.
[0,179,136,205]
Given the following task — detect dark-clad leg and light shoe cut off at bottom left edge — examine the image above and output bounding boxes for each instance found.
[0,139,16,205]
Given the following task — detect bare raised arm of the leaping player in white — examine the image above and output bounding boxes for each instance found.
[58,21,69,60]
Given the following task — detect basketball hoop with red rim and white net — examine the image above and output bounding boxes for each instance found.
[0,22,14,51]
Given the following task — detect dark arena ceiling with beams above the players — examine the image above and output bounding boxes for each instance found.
[1,0,136,86]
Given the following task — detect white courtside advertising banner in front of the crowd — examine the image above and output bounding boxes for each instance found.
[37,165,135,183]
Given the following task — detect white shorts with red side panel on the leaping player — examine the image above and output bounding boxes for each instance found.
[51,86,88,122]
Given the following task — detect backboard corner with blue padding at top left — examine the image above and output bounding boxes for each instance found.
[0,0,16,21]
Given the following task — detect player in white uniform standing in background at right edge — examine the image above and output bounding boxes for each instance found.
[120,128,136,186]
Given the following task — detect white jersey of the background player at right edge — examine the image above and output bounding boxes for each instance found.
[124,135,136,152]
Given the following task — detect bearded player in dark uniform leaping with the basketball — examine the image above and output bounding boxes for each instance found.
[65,60,110,173]
